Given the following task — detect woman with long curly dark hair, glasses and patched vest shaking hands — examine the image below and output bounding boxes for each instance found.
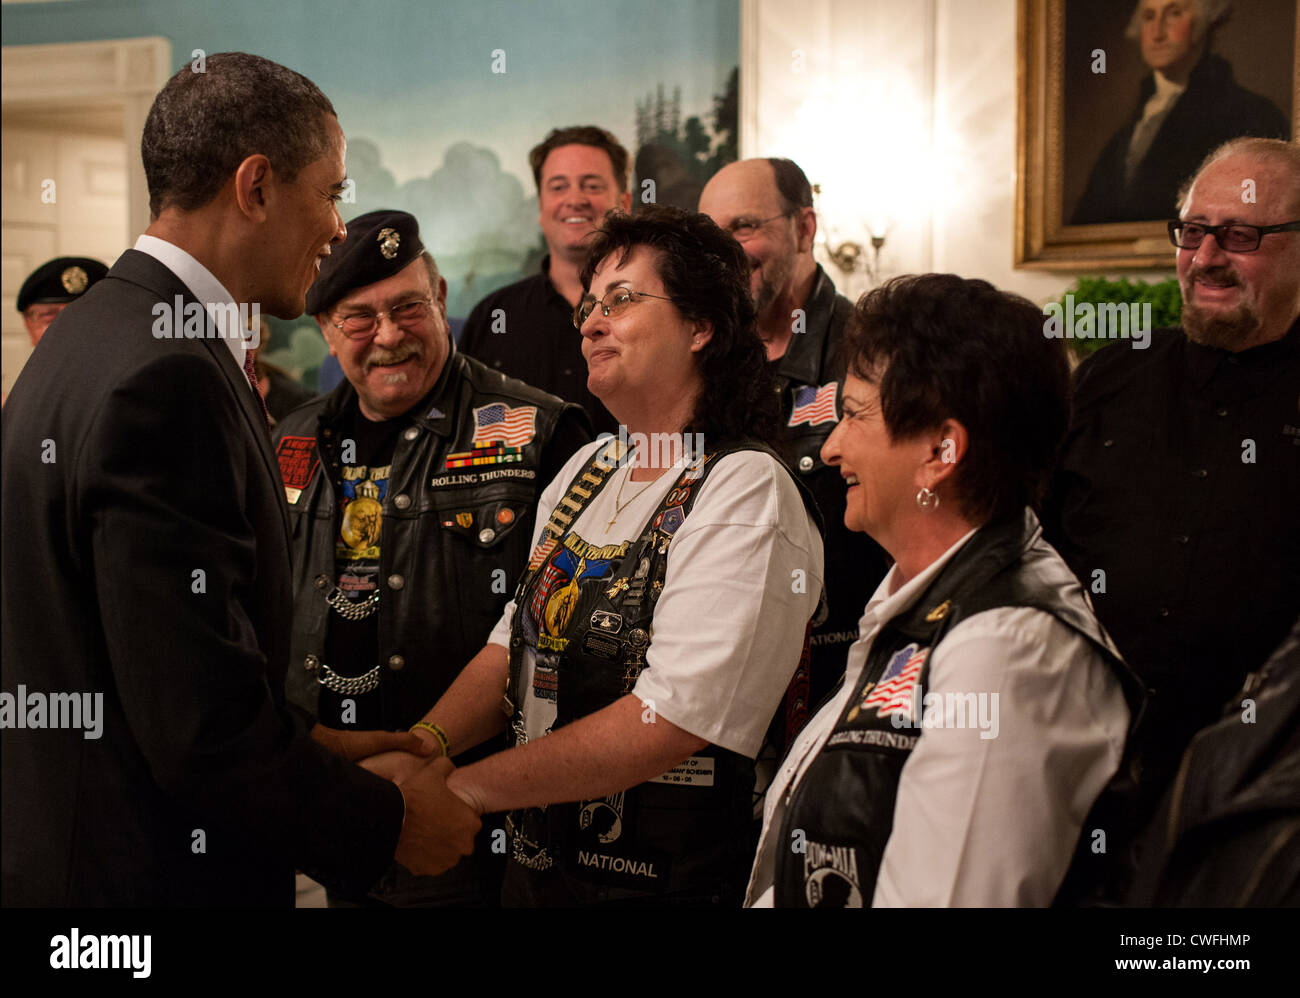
[371,208,822,906]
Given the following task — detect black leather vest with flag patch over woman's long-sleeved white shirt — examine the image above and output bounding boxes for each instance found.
[775,509,1139,908]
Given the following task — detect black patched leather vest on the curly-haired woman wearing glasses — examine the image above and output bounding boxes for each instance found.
[507,442,811,903]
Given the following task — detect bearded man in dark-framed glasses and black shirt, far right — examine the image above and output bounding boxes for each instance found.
[1044,138,1300,899]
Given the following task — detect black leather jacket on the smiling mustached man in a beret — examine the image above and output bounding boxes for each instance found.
[276,344,592,730]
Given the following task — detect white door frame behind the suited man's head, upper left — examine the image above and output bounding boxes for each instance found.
[0,36,172,242]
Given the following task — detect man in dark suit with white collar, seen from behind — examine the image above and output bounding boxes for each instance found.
[0,53,478,906]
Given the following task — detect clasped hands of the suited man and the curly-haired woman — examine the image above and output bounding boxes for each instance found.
[312,724,482,877]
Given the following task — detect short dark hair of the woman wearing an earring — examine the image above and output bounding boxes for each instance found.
[842,274,1070,522]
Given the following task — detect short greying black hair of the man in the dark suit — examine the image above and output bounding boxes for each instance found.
[140,52,338,218]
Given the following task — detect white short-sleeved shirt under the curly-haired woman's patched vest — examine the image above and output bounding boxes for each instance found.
[488,442,823,758]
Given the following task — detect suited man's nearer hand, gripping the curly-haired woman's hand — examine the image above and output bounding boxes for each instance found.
[393,758,482,877]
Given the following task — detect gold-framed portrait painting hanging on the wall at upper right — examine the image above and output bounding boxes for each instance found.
[1015,0,1300,270]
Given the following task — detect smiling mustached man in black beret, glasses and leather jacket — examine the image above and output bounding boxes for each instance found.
[276,211,590,906]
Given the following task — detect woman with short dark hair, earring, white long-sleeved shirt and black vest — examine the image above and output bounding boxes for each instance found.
[748,274,1128,907]
